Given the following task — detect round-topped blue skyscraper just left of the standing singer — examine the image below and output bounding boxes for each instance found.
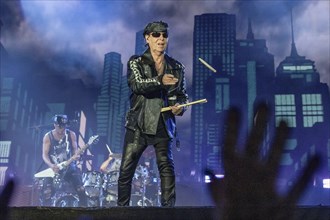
[96,52,128,152]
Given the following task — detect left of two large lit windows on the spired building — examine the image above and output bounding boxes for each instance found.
[275,94,297,127]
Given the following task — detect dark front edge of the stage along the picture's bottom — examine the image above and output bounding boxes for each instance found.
[5,206,330,220]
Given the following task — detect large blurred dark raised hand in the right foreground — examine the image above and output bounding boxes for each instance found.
[207,105,320,219]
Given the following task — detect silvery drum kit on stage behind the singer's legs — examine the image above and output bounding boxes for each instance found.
[35,156,160,207]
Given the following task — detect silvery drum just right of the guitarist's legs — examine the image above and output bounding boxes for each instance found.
[82,171,103,197]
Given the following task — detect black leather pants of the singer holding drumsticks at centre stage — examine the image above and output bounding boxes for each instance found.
[117,130,176,207]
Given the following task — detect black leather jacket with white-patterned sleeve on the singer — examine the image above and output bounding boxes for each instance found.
[125,49,188,138]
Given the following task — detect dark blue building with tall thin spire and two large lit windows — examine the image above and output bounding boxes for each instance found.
[272,12,330,201]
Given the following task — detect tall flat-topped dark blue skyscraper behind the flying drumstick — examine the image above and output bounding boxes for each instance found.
[191,13,236,174]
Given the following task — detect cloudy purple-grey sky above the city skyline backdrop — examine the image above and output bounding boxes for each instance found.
[1,0,330,127]
